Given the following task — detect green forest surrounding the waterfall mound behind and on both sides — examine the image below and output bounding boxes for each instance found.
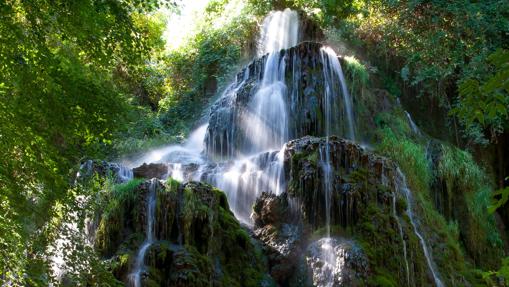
[0,0,509,286]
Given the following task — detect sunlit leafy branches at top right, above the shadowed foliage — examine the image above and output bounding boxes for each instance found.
[345,0,509,95]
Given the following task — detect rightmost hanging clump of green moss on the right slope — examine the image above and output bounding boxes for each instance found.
[436,144,503,268]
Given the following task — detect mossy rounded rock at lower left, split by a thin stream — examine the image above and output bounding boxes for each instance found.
[95,180,270,286]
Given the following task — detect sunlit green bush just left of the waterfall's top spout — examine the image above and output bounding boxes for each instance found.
[159,0,257,129]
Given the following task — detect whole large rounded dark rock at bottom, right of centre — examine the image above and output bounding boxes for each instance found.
[253,137,433,286]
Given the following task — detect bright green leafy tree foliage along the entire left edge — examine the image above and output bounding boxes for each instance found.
[0,0,171,285]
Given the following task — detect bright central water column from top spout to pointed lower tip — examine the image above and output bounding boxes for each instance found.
[194,9,299,224]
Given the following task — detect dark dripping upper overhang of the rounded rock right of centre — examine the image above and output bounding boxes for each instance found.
[284,136,395,232]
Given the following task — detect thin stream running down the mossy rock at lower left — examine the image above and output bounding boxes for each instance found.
[129,178,158,287]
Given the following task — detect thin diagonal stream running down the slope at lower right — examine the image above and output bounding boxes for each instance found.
[396,168,444,287]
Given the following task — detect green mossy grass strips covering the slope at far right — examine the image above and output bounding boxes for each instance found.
[377,108,501,284]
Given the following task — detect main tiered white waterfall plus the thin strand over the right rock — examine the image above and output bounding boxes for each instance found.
[120,9,362,227]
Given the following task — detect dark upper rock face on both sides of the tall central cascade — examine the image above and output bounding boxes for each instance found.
[205,42,356,158]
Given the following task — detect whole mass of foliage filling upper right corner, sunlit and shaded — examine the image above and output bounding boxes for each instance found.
[330,0,509,144]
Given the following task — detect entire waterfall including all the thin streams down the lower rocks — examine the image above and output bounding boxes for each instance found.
[108,9,452,287]
